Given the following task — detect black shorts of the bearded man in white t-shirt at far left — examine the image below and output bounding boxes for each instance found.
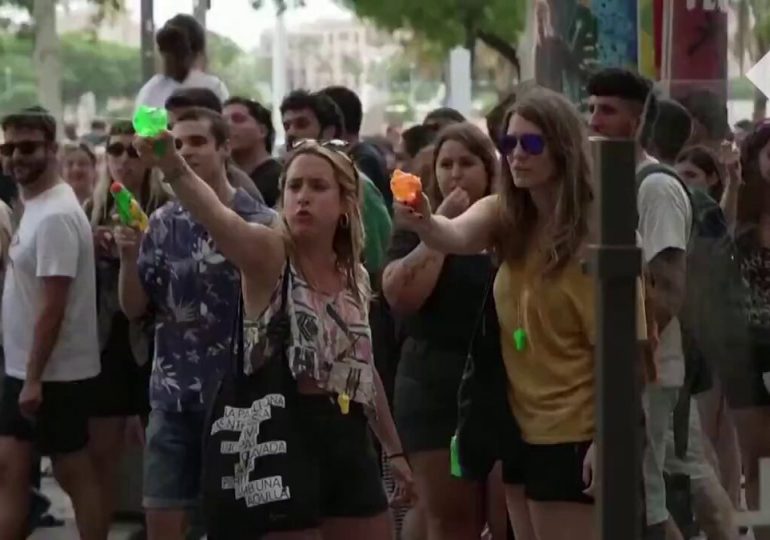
[0,377,92,456]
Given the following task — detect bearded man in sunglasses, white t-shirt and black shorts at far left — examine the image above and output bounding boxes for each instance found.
[0,107,108,540]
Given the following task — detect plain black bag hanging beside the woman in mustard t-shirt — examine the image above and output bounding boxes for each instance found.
[455,272,522,481]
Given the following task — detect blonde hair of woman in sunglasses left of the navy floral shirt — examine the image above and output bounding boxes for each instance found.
[86,121,174,227]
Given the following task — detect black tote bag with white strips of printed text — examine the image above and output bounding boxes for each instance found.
[202,264,320,540]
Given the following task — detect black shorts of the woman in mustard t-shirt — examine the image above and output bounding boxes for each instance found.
[503,441,594,504]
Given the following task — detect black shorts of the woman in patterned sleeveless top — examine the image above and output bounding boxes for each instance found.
[297,395,388,518]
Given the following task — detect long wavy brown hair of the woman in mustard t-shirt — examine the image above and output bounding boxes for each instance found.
[495,88,593,276]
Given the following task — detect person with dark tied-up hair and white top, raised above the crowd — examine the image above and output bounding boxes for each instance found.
[135,14,230,108]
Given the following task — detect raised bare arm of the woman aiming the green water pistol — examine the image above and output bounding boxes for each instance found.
[135,132,286,287]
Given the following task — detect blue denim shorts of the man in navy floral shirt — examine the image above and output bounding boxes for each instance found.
[142,409,206,510]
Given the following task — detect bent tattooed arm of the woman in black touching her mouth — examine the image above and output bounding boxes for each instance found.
[382,243,444,315]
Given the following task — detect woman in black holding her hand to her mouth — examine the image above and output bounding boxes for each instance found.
[383,122,506,540]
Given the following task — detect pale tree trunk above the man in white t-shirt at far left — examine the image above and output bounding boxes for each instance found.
[32,0,63,131]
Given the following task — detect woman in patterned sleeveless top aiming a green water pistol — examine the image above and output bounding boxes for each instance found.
[130,133,411,540]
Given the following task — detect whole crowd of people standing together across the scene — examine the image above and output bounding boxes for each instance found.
[0,10,770,540]
